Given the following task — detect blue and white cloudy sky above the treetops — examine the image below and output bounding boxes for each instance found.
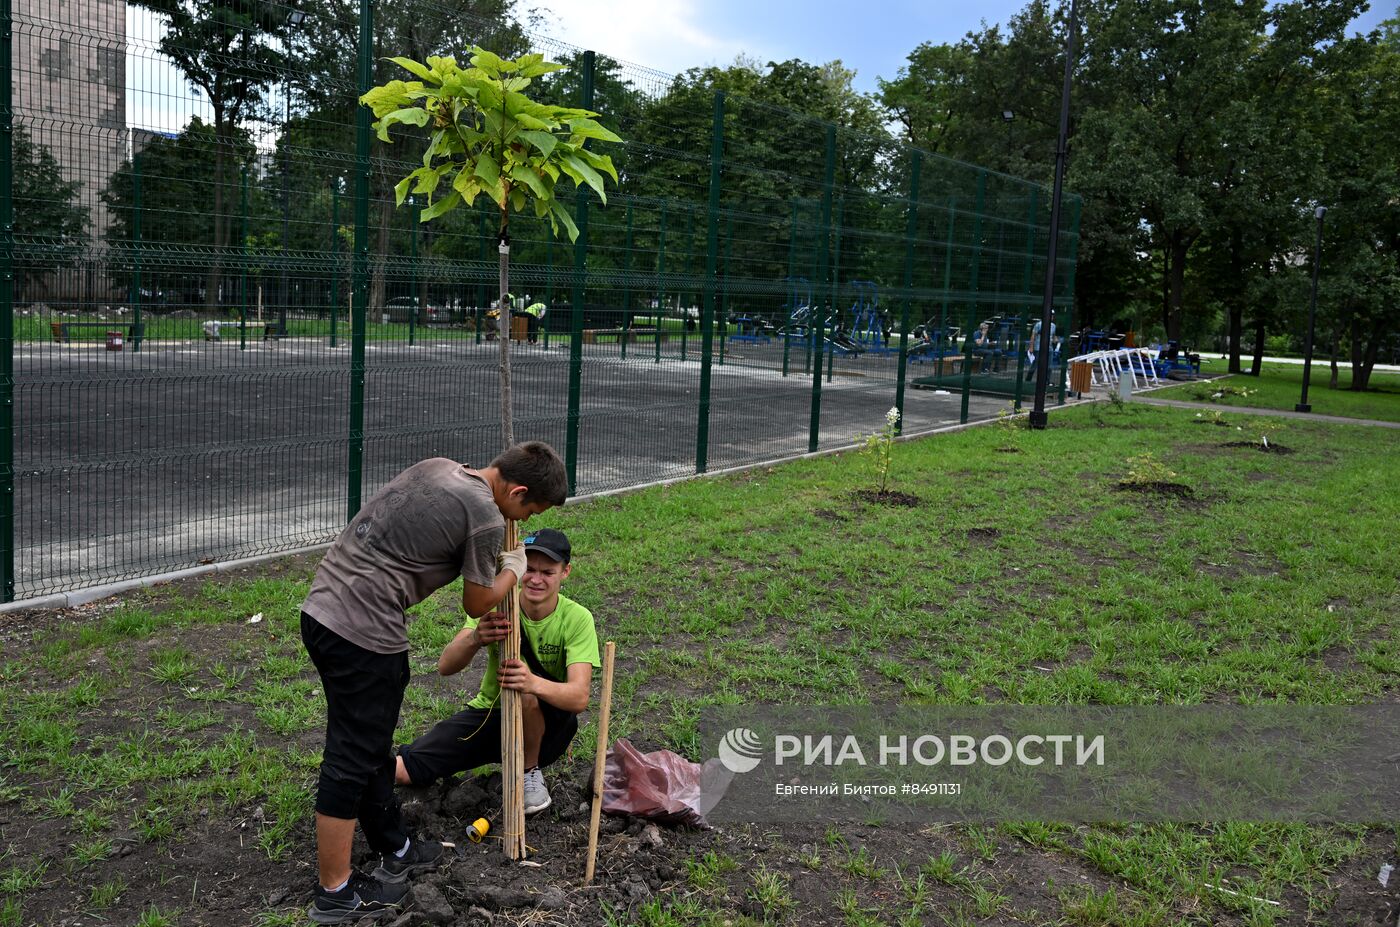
[522,0,1396,92]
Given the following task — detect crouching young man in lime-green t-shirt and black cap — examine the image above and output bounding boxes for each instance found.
[395,528,599,815]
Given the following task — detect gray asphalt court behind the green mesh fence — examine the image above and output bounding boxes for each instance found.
[5,337,1007,598]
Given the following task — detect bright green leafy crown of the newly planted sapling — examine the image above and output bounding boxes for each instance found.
[360,46,622,239]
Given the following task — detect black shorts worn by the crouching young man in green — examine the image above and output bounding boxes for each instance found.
[399,699,578,786]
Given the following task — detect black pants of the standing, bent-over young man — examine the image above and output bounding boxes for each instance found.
[301,612,409,853]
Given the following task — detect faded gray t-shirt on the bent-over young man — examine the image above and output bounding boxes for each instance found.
[301,456,505,654]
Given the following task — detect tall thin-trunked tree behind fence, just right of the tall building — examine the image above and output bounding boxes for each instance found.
[133,0,290,308]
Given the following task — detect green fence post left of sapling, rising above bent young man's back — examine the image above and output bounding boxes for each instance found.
[346,0,374,521]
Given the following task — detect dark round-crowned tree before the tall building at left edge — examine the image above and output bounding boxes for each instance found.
[11,125,90,300]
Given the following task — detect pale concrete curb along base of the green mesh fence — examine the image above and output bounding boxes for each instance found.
[0,399,1092,615]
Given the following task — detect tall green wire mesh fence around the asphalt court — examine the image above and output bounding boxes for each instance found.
[0,0,1079,601]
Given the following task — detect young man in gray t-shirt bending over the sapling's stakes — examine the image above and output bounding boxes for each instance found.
[301,441,568,924]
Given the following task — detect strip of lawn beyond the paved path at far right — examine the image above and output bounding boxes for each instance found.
[1152,360,1400,421]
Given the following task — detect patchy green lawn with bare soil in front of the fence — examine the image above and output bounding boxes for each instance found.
[0,406,1400,927]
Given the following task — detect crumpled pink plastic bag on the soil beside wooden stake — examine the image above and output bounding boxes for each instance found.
[603,738,734,829]
